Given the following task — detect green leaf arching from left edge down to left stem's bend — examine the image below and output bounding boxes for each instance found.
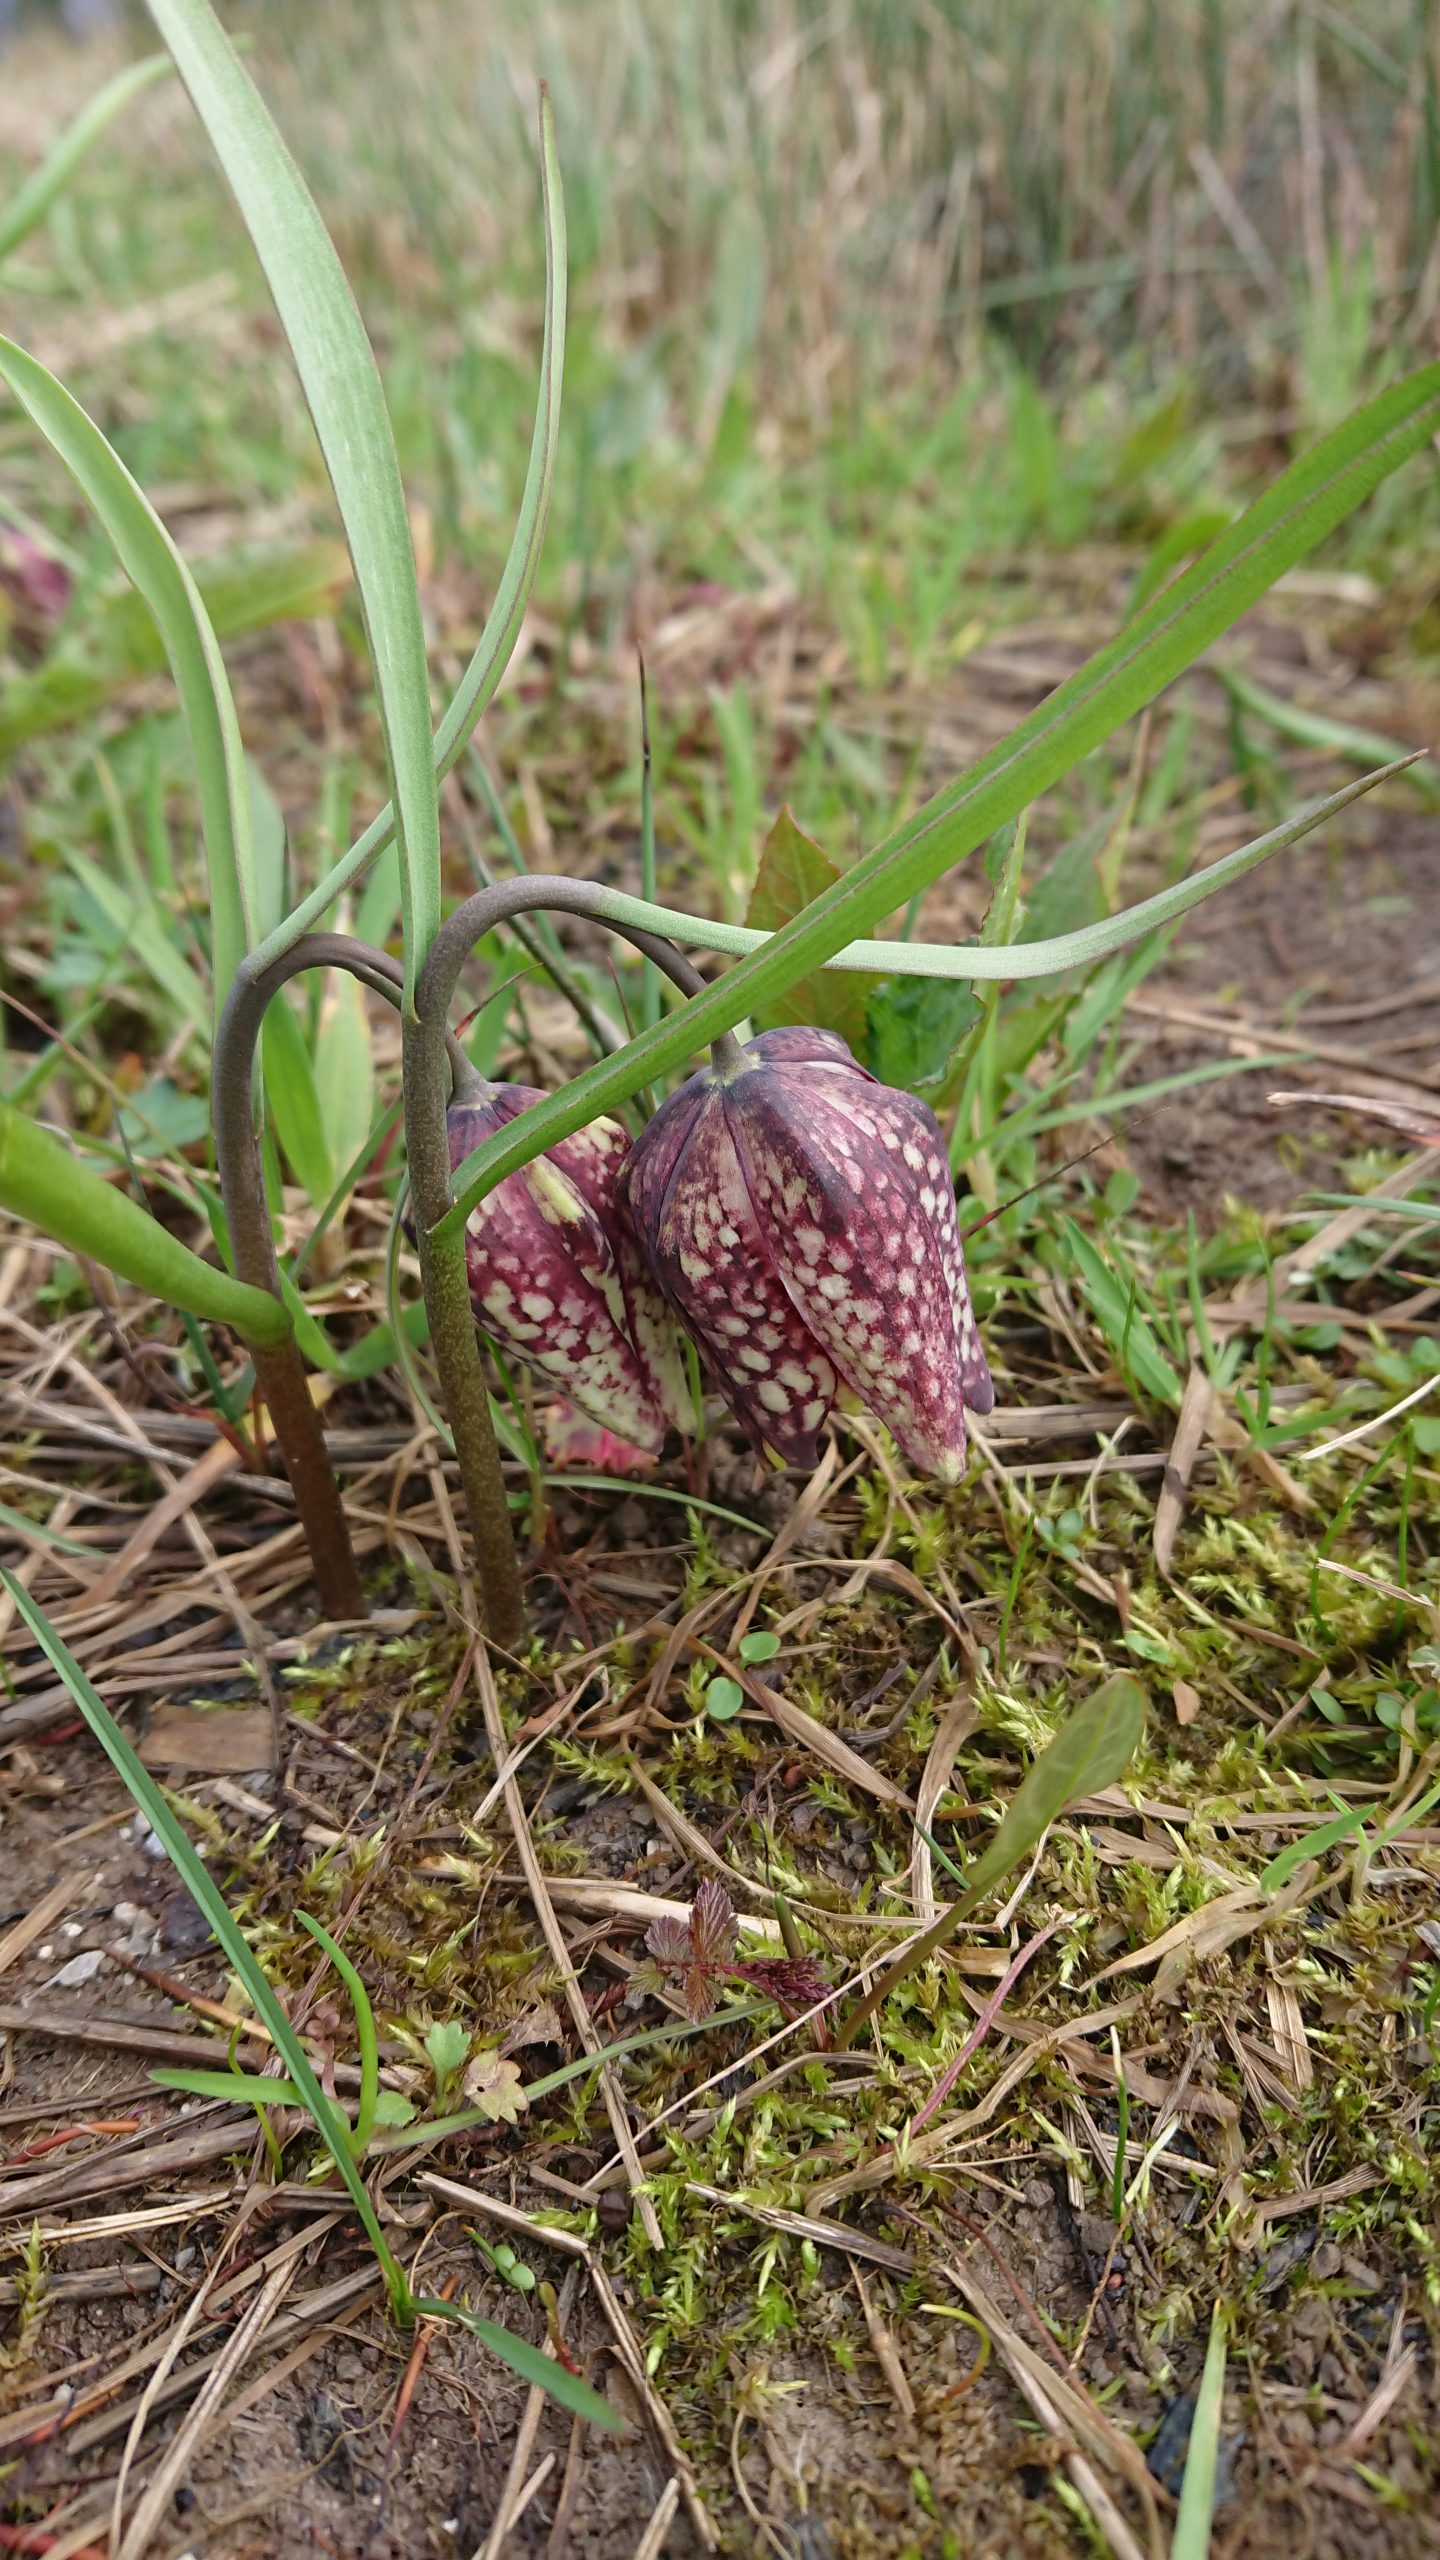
[0,338,256,1021]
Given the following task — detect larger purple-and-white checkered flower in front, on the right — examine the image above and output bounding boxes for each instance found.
[623,1029,994,1485]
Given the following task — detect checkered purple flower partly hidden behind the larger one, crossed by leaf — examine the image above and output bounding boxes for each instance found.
[446,1083,689,1454]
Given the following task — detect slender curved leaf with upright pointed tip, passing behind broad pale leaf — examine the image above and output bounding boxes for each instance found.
[245,90,566,960]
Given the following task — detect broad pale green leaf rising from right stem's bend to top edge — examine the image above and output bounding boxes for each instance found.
[149,0,441,1004]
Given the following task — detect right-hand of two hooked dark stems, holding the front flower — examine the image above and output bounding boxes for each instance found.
[402,873,722,1644]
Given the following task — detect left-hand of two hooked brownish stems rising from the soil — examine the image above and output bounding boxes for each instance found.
[210,934,474,1618]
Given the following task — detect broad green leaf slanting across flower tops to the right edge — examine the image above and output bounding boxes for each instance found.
[443,348,1440,1236]
